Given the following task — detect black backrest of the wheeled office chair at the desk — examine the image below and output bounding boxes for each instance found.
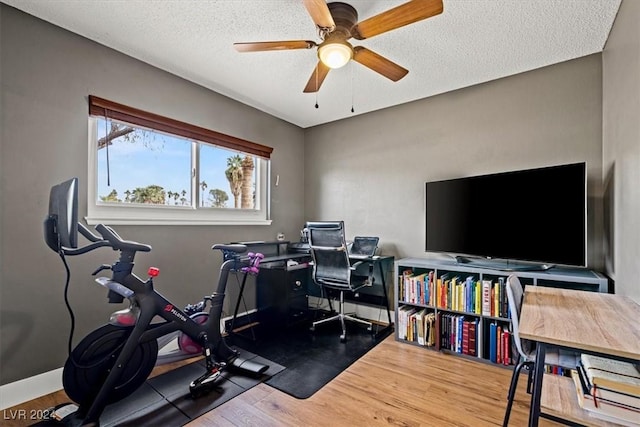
[306,221,351,289]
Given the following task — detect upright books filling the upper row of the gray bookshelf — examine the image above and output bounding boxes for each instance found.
[398,270,510,318]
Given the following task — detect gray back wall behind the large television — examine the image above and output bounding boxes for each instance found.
[305,54,603,269]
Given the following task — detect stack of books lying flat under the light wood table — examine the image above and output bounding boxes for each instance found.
[571,354,640,426]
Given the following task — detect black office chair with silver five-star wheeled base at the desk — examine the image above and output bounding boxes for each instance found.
[306,221,372,342]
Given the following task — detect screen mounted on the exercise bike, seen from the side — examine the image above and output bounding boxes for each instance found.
[44,178,78,252]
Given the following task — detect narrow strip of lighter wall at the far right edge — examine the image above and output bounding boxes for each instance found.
[602,0,640,302]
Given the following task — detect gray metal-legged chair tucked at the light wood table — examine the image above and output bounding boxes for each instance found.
[502,274,579,427]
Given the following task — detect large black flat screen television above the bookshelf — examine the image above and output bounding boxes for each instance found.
[425,163,587,266]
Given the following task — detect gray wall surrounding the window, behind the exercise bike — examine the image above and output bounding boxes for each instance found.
[0,5,304,384]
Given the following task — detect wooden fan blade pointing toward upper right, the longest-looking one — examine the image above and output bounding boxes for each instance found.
[351,0,443,40]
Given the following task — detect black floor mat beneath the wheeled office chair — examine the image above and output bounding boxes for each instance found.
[234,321,393,399]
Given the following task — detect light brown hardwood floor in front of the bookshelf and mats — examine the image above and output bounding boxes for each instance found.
[2,336,558,427]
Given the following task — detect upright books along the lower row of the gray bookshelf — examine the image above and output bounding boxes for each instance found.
[396,305,514,365]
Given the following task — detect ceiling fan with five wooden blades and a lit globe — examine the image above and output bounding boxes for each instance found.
[233,0,443,92]
